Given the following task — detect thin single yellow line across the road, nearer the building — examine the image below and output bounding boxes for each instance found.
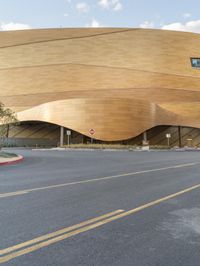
[0,162,200,198]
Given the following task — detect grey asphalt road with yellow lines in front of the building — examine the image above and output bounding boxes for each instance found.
[0,150,200,266]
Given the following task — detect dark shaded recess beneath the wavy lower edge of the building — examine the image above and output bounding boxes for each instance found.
[4,121,200,147]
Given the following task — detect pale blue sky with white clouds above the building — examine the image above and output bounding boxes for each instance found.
[0,0,200,33]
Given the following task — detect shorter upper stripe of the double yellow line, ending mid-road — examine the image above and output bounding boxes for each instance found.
[0,210,124,255]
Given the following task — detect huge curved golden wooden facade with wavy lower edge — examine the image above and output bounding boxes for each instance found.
[0,28,200,141]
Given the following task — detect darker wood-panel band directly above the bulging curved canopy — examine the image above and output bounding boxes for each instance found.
[1,88,200,110]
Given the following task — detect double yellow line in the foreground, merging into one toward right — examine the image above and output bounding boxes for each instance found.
[0,184,200,264]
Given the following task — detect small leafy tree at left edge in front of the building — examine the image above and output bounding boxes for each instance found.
[0,102,18,149]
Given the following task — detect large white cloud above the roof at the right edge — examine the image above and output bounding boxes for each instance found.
[162,20,200,33]
